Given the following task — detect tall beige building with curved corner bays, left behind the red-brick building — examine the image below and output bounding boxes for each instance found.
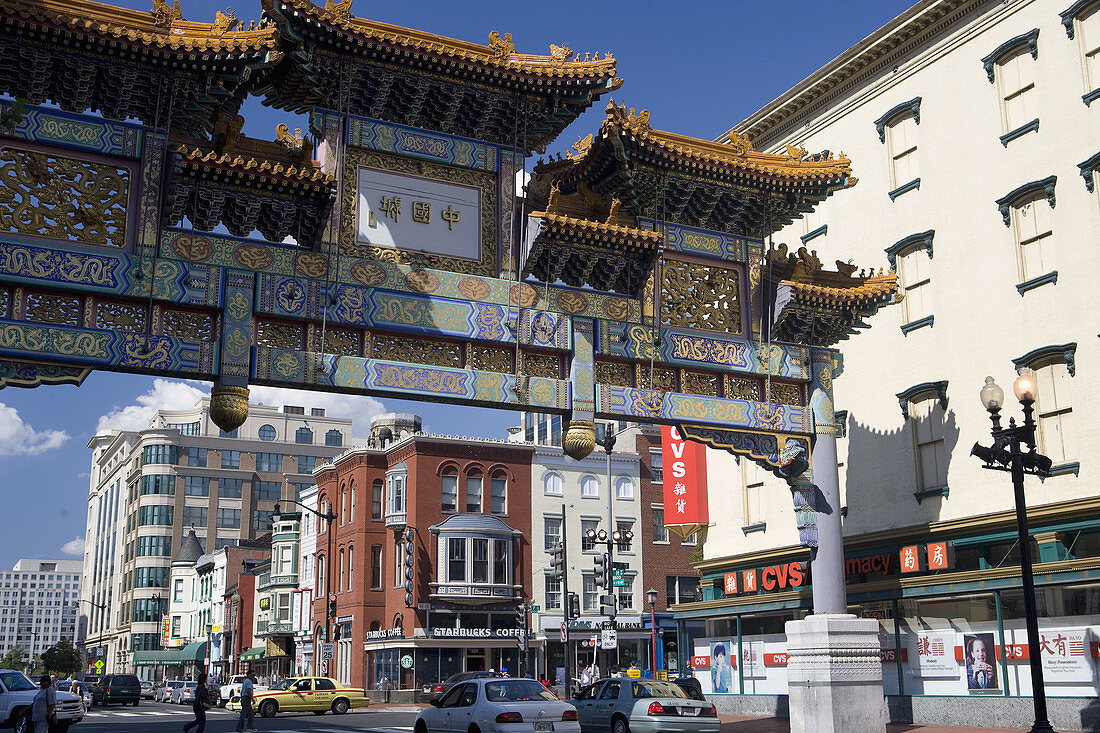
[81,398,352,671]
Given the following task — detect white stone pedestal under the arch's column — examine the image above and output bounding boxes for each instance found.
[787,613,887,733]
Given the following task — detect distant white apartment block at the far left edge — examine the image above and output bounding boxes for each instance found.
[0,558,84,659]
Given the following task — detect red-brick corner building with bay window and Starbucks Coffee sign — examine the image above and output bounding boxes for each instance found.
[315,414,534,690]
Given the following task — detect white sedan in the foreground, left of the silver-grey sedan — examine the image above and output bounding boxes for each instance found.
[415,677,581,733]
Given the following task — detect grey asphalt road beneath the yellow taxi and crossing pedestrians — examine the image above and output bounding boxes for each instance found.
[70,700,418,733]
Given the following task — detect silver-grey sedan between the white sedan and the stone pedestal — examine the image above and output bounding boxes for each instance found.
[573,677,719,733]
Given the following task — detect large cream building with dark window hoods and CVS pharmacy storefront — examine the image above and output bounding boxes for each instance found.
[679,0,1100,717]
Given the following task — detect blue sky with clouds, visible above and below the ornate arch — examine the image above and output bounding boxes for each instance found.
[0,0,910,567]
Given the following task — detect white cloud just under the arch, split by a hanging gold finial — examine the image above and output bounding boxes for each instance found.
[94,380,386,435]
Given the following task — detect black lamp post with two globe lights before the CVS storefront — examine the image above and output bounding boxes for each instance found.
[970,370,1054,733]
